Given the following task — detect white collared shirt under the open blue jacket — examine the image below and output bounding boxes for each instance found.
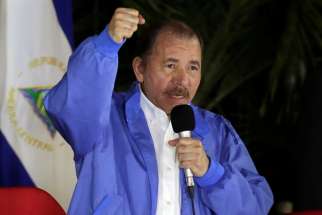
[140,90,181,215]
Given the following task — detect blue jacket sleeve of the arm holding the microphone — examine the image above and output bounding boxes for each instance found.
[200,117,273,215]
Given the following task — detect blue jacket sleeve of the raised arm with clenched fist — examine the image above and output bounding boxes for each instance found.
[44,28,122,160]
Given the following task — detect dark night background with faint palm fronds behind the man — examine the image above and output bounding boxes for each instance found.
[73,0,322,214]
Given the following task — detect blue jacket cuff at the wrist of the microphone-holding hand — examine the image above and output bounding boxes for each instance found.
[194,158,225,187]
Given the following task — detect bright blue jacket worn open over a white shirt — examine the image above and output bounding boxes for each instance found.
[44,31,273,215]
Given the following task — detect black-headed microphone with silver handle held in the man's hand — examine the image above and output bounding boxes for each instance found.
[170,105,195,199]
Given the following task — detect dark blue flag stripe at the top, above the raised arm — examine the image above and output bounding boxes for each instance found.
[53,0,74,49]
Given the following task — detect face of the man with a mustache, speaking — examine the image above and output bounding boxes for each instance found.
[133,32,201,114]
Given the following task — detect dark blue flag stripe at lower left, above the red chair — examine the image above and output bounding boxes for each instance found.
[0,131,34,187]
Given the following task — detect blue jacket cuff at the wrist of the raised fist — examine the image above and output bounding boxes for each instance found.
[94,26,125,55]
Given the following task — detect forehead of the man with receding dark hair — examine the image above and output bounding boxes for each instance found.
[152,32,201,61]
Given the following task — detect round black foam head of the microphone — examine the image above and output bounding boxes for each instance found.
[170,105,195,133]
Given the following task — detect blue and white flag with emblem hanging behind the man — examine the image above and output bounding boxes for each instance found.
[0,0,76,209]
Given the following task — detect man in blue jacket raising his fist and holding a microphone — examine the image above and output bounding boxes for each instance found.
[45,8,272,215]
